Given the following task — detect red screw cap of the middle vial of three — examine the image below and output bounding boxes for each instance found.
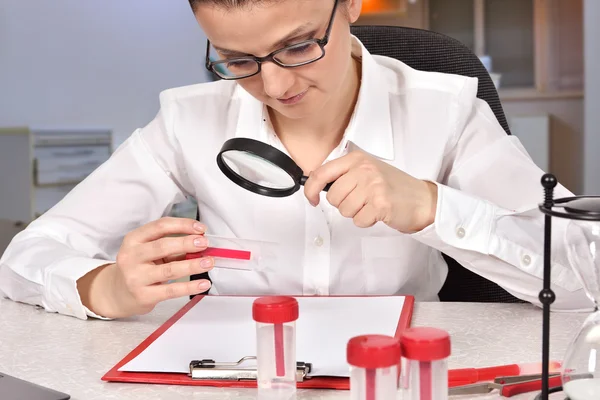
[346,335,401,369]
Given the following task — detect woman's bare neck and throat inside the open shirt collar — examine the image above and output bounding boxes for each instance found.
[269,58,361,173]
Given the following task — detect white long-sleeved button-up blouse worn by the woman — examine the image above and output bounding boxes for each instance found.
[0,38,593,319]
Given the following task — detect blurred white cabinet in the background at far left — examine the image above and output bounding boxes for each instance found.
[0,128,112,224]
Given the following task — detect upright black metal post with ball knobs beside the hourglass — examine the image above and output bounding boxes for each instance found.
[539,174,557,400]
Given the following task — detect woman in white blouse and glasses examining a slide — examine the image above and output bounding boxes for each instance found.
[0,0,591,318]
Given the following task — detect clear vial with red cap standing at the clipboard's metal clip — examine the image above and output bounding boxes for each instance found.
[252,296,298,400]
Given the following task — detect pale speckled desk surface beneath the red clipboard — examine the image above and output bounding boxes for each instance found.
[0,299,587,400]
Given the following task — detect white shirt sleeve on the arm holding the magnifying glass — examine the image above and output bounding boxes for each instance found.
[413,80,593,311]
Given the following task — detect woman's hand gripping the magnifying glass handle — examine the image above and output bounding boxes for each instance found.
[304,151,437,233]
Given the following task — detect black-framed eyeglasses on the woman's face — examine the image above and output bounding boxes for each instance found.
[206,0,338,80]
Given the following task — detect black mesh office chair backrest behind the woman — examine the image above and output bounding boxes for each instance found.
[351,25,522,303]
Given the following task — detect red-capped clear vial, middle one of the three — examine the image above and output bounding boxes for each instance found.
[346,335,401,400]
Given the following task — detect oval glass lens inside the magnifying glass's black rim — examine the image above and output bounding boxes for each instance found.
[222,150,296,189]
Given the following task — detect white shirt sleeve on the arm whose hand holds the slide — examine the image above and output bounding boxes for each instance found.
[0,104,188,319]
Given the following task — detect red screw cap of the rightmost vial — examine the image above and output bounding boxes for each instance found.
[400,327,451,361]
